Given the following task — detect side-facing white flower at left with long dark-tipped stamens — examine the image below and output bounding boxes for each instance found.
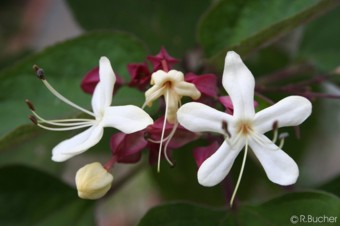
[27,57,153,162]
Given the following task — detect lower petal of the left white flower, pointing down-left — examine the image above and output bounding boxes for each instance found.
[52,126,104,162]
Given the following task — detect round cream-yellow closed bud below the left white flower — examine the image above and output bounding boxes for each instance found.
[76,162,113,199]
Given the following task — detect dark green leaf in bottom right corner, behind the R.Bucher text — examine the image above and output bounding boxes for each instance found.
[236,192,340,226]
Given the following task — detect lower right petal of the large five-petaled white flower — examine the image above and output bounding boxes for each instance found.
[249,134,299,186]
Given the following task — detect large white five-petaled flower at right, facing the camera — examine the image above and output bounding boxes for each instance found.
[177,51,312,204]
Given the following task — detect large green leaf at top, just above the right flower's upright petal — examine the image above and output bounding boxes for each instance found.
[198,0,339,57]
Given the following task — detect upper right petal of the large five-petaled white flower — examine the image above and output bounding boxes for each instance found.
[254,96,312,133]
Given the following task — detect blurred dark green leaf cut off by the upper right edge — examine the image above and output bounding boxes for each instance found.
[298,7,340,71]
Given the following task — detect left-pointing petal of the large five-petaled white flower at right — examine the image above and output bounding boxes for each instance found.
[177,102,233,134]
